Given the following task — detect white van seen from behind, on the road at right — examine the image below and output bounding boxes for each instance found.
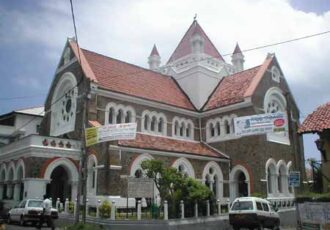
[229,197,280,230]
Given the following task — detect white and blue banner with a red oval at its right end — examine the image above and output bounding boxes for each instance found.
[234,113,288,137]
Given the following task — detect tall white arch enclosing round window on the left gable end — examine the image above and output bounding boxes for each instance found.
[50,72,78,136]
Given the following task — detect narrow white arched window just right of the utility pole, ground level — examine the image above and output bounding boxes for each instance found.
[87,154,97,195]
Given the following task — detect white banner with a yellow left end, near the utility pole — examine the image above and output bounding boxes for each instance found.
[85,123,136,146]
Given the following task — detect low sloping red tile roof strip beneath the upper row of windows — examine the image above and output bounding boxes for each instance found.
[118,133,227,158]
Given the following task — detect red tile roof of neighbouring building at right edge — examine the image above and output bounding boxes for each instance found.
[298,102,330,133]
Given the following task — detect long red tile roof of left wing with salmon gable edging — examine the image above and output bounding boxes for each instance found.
[70,41,195,110]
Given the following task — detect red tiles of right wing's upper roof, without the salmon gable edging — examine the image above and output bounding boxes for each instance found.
[203,66,260,110]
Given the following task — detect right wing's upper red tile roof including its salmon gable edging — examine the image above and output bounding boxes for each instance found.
[203,56,274,111]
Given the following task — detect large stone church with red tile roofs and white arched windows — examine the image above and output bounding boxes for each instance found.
[0,21,304,208]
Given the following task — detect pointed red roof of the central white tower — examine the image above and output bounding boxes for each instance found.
[167,20,224,63]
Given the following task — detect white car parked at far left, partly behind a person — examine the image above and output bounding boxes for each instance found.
[8,199,58,225]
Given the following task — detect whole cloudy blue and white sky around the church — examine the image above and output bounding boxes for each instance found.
[0,0,330,162]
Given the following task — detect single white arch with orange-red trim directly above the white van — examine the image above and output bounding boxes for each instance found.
[229,164,251,201]
